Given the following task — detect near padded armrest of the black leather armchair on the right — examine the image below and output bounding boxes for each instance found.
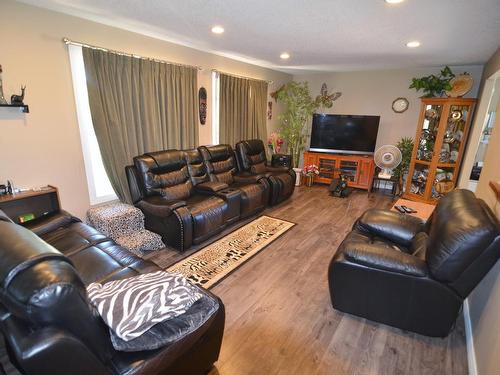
[339,242,428,277]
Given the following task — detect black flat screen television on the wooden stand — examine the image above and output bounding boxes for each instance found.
[309,114,380,154]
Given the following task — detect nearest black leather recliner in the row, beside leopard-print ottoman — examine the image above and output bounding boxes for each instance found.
[126,150,231,251]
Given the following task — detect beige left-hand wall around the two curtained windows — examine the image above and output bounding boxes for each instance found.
[0,0,291,217]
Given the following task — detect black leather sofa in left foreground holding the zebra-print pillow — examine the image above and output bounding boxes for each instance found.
[0,211,224,375]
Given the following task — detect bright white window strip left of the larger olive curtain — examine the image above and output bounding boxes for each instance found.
[68,45,118,205]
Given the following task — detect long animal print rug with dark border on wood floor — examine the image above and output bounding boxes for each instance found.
[167,215,295,289]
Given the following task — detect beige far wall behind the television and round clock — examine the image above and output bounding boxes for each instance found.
[293,65,482,153]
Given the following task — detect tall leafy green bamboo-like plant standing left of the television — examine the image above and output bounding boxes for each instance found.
[276,81,320,168]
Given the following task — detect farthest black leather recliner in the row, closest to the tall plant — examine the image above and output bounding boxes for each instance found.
[236,139,295,205]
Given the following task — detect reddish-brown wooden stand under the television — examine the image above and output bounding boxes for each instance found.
[304,151,375,190]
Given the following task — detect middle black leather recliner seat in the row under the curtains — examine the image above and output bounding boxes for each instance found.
[199,145,269,217]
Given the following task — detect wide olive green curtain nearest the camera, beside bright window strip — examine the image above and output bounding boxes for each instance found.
[83,47,198,202]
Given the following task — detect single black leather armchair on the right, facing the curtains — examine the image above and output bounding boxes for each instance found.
[328,190,500,337]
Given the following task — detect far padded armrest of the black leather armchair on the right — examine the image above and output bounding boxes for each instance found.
[354,208,424,247]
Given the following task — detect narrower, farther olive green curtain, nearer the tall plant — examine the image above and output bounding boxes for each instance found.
[219,73,267,146]
